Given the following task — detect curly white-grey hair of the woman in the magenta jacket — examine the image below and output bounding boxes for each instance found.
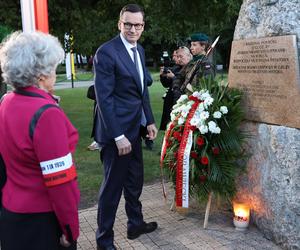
[0,31,64,89]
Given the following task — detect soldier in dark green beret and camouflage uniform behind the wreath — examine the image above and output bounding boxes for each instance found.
[173,33,215,102]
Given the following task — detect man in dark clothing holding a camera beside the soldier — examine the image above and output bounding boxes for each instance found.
[159,46,192,130]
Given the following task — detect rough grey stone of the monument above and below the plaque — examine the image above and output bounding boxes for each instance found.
[234,0,300,249]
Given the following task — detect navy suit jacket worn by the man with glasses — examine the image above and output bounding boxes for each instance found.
[94,36,154,145]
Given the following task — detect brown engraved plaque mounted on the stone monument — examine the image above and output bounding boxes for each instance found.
[228,35,300,128]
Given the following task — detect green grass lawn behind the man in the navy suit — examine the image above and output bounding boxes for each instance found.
[56,73,165,208]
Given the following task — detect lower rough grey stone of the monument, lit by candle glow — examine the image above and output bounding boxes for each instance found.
[237,122,300,249]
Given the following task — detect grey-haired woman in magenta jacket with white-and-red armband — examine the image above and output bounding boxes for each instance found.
[0,32,79,250]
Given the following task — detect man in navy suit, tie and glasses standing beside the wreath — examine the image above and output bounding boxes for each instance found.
[94,4,157,249]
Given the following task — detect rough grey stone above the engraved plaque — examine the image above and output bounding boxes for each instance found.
[234,0,300,65]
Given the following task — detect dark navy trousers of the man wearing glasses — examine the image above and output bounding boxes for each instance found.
[96,138,144,247]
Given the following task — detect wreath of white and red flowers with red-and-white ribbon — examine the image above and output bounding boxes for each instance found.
[161,80,247,207]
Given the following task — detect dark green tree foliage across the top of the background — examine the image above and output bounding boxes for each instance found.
[0,0,242,68]
